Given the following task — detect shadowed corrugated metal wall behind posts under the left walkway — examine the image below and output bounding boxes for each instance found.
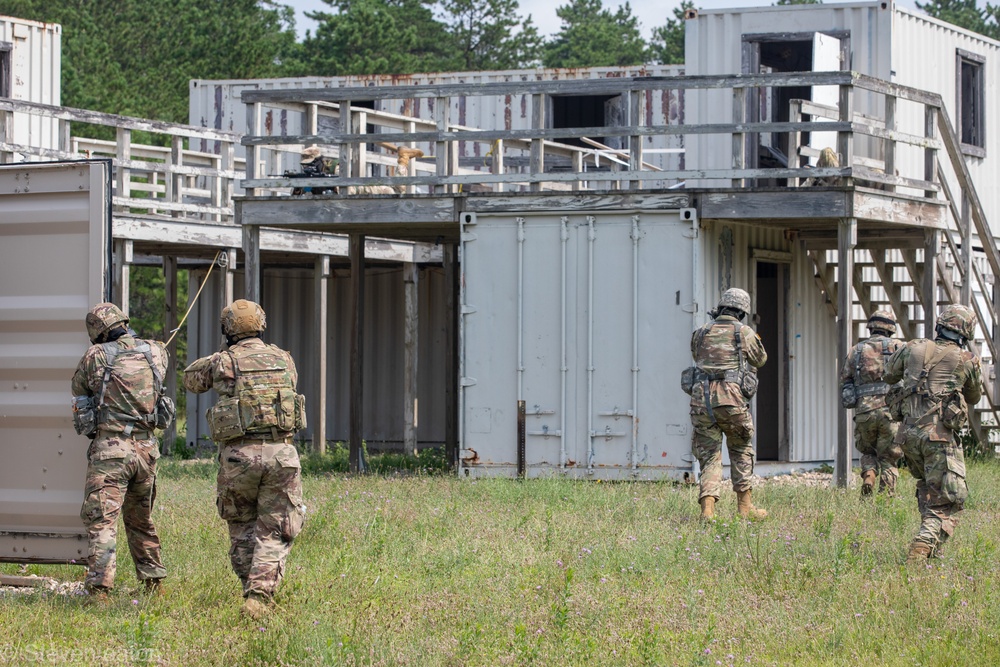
[187,265,447,447]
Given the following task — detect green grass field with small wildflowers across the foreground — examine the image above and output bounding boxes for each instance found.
[0,462,1000,667]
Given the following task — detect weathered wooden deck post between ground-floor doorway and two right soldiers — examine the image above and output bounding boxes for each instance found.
[834,218,858,488]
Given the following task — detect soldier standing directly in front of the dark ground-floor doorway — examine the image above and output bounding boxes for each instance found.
[691,288,767,520]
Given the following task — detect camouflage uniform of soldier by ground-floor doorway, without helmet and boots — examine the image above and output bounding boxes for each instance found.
[691,315,767,500]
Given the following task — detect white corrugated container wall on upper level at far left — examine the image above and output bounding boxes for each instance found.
[0,16,62,148]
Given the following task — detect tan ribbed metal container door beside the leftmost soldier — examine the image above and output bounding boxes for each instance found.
[0,161,111,562]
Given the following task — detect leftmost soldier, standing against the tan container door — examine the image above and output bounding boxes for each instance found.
[72,303,167,595]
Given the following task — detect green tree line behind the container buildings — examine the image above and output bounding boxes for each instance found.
[0,0,1000,123]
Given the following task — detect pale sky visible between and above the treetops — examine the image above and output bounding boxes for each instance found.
[279,0,916,39]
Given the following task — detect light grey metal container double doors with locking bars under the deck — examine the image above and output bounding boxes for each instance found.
[460,210,694,479]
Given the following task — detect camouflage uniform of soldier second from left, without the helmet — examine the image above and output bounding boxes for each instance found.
[184,337,305,599]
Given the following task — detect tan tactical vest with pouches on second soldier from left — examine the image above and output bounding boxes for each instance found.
[207,345,306,442]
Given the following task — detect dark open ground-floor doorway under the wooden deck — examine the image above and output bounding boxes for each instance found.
[754,260,789,461]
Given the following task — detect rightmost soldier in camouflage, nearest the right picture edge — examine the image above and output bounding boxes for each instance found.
[885,305,982,562]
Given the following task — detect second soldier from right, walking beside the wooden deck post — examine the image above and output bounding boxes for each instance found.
[840,310,903,496]
